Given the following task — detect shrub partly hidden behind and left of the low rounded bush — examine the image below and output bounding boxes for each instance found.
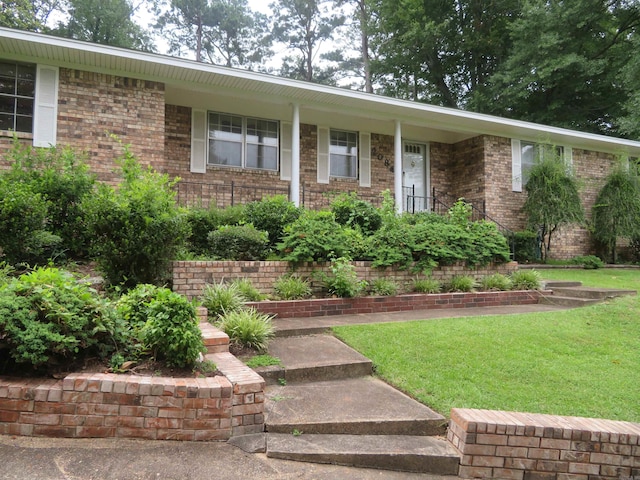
[186,204,245,255]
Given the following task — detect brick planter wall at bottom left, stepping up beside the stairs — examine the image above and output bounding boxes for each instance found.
[0,324,265,441]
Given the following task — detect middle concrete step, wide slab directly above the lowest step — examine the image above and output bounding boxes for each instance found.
[265,377,446,435]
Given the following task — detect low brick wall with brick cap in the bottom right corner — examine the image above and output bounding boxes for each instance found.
[448,408,640,480]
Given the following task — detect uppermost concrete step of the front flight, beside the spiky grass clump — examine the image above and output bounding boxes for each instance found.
[256,335,372,384]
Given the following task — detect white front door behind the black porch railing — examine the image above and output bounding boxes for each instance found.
[402,142,430,212]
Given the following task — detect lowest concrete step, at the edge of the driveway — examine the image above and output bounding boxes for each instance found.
[267,433,460,475]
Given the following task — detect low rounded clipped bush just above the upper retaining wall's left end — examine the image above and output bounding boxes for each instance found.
[207,224,269,260]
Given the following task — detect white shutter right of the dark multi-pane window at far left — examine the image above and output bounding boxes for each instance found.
[33,65,58,147]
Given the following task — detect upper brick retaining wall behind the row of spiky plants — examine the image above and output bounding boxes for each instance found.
[172,261,518,298]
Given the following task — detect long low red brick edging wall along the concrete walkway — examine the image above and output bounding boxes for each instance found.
[247,291,550,318]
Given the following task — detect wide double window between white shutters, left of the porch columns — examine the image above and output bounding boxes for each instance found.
[207,112,279,171]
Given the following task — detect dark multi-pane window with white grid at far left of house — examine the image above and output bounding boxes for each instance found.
[0,62,36,133]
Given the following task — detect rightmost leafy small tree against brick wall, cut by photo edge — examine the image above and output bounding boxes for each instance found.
[593,164,640,263]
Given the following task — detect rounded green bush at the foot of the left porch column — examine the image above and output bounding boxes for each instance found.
[245,195,300,247]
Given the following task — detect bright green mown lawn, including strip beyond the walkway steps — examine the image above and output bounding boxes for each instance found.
[334,269,640,422]
